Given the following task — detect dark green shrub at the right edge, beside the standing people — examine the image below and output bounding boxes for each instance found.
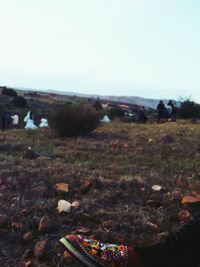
[178,99,200,119]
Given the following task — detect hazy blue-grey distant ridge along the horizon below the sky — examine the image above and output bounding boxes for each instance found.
[16,88,177,109]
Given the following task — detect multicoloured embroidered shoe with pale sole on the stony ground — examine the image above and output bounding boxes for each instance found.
[60,235,128,267]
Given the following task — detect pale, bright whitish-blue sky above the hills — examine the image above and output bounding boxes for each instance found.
[0,0,200,102]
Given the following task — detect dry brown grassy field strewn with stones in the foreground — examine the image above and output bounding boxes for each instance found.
[0,122,200,267]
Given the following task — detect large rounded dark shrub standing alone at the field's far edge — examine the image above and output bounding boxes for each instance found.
[53,104,99,137]
